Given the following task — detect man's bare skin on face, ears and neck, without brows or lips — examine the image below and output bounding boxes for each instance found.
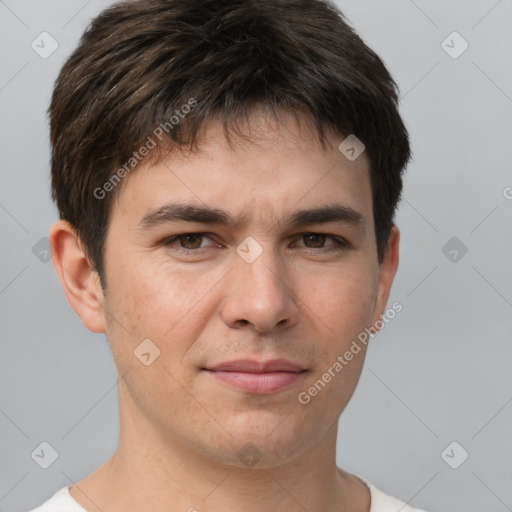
[50,113,399,512]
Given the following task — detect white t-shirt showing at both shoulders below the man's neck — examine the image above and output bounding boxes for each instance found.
[29,475,425,512]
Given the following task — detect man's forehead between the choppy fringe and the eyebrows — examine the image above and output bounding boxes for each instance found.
[112,114,372,234]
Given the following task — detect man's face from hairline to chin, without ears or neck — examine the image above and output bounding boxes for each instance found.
[99,111,394,467]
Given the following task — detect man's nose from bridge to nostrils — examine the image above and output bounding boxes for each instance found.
[221,248,299,332]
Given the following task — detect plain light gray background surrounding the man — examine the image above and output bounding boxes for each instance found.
[0,0,512,512]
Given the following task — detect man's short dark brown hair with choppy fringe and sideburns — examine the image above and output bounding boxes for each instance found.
[49,0,410,286]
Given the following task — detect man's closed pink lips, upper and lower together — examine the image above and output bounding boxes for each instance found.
[204,359,306,395]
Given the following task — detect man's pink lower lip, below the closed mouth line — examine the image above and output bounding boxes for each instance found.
[208,370,305,395]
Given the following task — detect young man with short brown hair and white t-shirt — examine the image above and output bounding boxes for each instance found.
[29,0,428,512]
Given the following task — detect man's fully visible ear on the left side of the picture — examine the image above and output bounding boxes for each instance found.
[48,219,106,333]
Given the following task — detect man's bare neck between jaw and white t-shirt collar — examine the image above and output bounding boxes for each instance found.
[70,386,370,512]
